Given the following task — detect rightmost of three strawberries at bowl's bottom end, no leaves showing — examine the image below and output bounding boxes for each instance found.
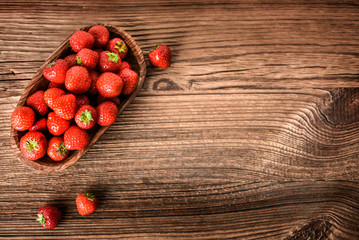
[64,126,90,150]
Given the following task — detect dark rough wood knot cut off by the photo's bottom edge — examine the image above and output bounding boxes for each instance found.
[285,219,333,240]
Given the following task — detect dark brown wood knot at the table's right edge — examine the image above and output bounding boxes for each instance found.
[319,88,359,125]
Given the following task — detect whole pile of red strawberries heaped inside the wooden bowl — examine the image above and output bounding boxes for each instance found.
[11,25,142,161]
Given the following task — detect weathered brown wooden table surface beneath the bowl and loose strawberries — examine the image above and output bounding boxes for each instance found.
[0,0,359,240]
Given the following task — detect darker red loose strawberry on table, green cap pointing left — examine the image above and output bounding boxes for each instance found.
[36,206,62,229]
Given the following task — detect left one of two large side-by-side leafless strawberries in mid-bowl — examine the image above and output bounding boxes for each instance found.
[65,66,91,94]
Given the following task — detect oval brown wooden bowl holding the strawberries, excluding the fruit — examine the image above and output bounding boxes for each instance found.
[10,24,146,173]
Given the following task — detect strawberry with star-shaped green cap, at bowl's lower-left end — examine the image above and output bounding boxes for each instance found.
[20,132,47,160]
